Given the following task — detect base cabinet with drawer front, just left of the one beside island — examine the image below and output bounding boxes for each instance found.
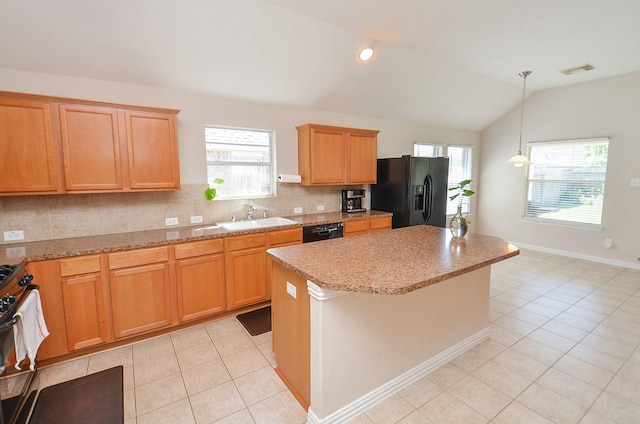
[175,239,226,322]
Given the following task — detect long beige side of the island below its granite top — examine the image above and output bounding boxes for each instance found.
[310,267,490,422]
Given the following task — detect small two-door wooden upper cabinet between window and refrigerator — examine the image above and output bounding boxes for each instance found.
[296,124,379,185]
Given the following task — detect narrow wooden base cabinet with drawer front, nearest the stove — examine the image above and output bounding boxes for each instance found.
[60,255,109,351]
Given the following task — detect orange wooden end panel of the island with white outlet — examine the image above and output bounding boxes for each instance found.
[271,262,310,408]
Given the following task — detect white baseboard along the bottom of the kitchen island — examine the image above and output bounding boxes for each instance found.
[307,327,490,424]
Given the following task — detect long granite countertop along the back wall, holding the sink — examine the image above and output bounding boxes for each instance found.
[0,211,392,264]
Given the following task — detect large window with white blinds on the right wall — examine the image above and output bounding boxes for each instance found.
[523,138,609,227]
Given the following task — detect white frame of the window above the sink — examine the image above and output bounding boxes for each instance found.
[204,124,277,200]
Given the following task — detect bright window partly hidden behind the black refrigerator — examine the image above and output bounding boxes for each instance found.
[413,143,473,215]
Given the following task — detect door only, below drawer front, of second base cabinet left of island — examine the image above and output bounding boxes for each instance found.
[176,254,225,322]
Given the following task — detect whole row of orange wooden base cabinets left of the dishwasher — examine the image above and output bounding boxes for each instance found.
[27,225,316,361]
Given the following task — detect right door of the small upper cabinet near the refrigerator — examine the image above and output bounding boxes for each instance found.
[346,131,378,184]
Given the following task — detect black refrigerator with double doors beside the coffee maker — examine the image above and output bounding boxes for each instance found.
[371,156,449,228]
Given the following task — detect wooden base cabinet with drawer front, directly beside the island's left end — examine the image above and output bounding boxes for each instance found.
[225,233,268,309]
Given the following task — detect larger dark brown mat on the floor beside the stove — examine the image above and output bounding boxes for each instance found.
[29,366,124,424]
